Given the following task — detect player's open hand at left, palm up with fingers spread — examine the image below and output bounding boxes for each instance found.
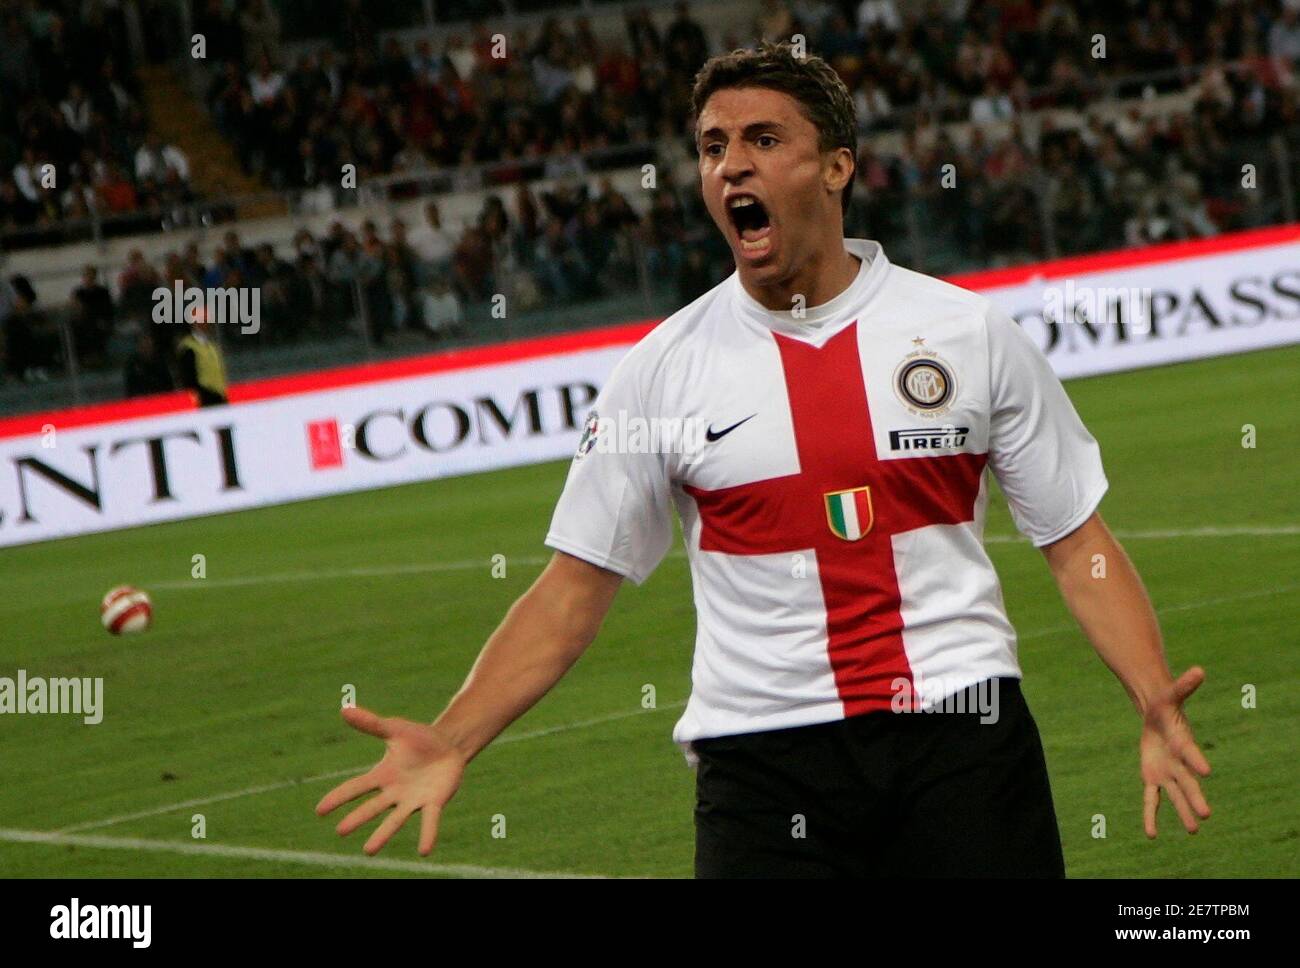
[316,707,465,856]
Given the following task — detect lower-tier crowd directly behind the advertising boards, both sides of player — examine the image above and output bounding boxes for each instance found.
[0,38,1300,392]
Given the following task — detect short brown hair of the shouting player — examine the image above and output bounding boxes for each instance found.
[690,40,858,214]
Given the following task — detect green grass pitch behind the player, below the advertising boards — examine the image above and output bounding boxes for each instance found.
[0,348,1300,877]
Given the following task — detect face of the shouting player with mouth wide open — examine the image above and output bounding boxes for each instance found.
[697,87,848,285]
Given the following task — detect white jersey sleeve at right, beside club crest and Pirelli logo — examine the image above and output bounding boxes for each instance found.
[987,308,1108,547]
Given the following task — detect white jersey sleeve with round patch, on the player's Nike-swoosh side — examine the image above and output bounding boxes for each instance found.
[546,357,672,585]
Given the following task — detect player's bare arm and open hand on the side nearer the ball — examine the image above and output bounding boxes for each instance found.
[316,552,623,855]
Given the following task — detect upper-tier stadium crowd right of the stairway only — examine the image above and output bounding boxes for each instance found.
[200,0,1300,188]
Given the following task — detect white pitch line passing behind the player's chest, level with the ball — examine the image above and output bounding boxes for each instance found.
[140,525,1300,591]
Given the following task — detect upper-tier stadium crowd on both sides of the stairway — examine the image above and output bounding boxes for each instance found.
[10,0,1300,237]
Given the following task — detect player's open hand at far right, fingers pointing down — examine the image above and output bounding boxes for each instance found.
[1140,665,1210,837]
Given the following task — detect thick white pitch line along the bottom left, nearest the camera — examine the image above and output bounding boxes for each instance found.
[0,828,603,878]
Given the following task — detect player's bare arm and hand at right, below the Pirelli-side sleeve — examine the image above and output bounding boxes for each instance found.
[1043,513,1210,837]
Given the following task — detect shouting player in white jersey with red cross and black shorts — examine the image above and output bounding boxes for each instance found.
[317,44,1210,877]
